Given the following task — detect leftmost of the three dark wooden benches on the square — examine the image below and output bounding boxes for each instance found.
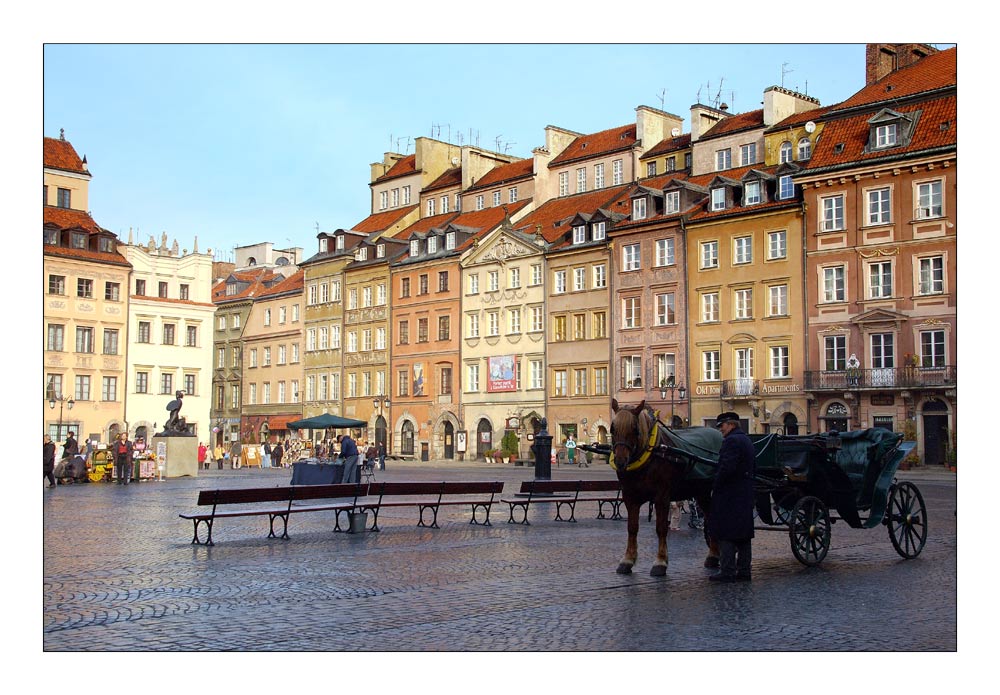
[179,483,368,545]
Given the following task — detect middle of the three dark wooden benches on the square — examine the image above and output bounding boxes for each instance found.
[358,480,503,531]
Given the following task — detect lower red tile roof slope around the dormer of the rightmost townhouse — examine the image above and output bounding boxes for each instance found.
[807,93,958,172]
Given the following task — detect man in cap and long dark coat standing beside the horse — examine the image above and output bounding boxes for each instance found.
[707,412,755,582]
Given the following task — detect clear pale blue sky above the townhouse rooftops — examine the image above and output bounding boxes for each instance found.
[43,44,884,260]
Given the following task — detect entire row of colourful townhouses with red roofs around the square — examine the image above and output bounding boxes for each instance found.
[45,44,958,464]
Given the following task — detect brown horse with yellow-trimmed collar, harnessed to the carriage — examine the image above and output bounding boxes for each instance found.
[610,399,722,577]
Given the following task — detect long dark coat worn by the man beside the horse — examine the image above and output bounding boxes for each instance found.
[708,427,756,541]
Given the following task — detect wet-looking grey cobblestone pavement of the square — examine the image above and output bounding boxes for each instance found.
[43,462,957,651]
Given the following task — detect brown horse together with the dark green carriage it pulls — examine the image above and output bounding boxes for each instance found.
[585,401,927,576]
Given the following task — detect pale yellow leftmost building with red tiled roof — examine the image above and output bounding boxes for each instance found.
[42,136,131,442]
